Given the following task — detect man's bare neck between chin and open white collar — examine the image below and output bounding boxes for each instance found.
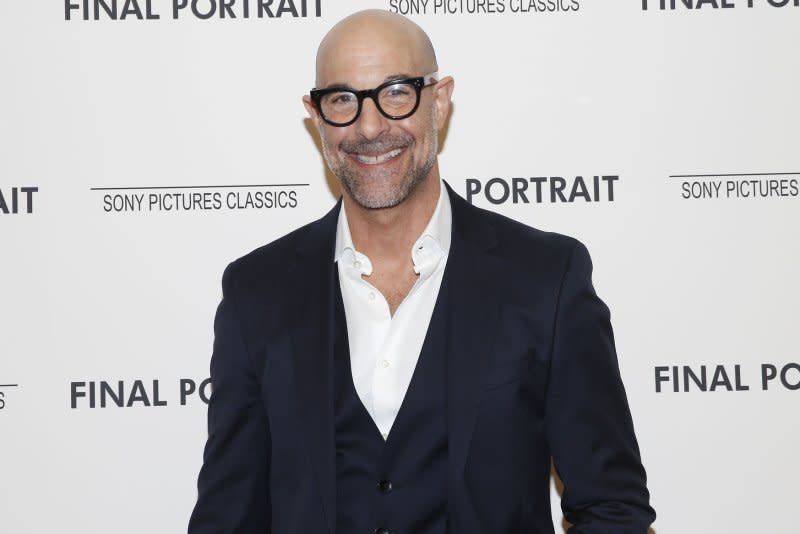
[342,169,441,265]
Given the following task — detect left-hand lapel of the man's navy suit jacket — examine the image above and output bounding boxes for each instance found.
[287,201,341,533]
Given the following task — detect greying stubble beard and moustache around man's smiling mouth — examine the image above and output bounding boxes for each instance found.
[322,116,438,209]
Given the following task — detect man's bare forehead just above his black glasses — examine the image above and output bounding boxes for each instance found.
[317,31,425,89]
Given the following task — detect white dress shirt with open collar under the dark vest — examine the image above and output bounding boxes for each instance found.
[335,182,453,439]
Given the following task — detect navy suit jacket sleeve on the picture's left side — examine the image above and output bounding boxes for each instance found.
[189,266,271,534]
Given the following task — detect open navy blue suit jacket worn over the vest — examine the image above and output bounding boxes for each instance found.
[189,183,655,534]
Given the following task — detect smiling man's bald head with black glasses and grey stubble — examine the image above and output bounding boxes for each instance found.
[303,10,453,213]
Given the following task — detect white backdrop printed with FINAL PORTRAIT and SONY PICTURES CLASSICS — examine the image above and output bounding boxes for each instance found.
[0,0,800,534]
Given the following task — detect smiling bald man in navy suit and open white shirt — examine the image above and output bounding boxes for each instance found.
[189,10,655,534]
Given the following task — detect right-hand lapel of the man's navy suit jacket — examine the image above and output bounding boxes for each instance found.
[440,186,502,480]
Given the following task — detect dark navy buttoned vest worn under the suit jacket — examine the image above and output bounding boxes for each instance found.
[334,273,448,534]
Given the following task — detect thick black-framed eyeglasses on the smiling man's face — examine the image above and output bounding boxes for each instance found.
[311,72,439,126]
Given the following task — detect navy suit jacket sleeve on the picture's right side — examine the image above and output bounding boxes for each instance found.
[546,242,655,534]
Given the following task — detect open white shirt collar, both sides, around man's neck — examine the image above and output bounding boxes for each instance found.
[334,180,453,278]
